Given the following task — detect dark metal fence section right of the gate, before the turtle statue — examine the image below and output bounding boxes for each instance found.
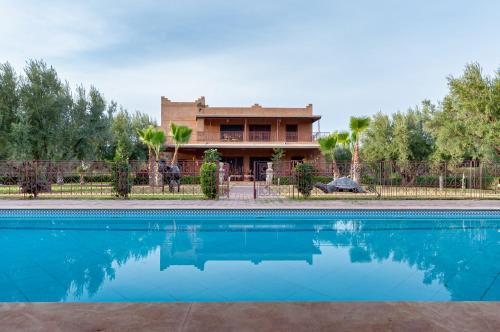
[254,161,500,200]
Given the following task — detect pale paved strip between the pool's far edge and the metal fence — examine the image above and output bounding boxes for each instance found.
[0,199,500,210]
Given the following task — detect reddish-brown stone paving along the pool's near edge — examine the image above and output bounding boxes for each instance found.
[0,302,500,332]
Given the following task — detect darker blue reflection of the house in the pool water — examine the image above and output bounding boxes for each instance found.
[160,226,321,270]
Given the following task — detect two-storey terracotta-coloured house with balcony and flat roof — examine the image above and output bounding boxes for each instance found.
[161,97,321,180]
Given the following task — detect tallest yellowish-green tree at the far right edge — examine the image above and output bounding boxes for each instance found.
[431,63,500,161]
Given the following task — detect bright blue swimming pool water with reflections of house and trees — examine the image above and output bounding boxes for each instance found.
[0,210,500,302]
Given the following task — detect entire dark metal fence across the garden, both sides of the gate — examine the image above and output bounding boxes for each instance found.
[0,160,500,200]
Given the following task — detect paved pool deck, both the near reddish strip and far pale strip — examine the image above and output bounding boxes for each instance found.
[0,200,500,332]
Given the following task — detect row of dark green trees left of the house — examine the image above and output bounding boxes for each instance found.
[0,60,152,160]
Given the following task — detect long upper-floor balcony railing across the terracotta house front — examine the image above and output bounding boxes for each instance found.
[186,131,330,143]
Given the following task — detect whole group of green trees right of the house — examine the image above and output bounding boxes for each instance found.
[361,63,500,163]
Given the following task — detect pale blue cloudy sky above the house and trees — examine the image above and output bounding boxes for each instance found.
[0,0,500,131]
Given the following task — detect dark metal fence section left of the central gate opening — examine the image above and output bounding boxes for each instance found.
[0,160,226,199]
